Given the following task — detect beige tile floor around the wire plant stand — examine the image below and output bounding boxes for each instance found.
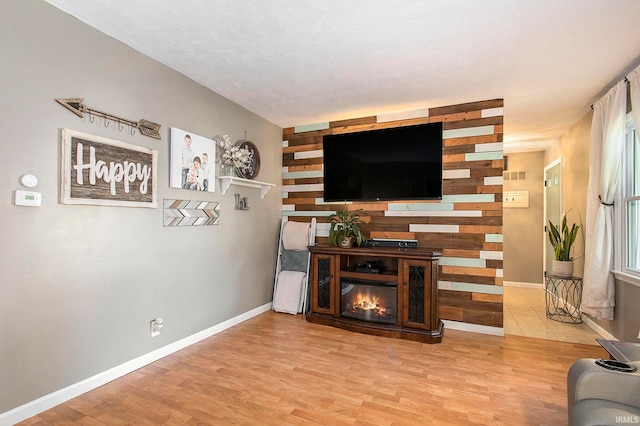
[504,286,600,345]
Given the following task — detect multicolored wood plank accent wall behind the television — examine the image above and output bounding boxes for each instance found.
[282,99,504,328]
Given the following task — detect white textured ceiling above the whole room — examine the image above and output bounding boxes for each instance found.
[47,0,640,152]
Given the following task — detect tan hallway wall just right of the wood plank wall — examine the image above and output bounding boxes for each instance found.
[502,151,544,284]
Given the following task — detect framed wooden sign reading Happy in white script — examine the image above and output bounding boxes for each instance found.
[60,129,158,208]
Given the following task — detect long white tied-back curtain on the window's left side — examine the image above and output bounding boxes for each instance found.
[581,81,627,319]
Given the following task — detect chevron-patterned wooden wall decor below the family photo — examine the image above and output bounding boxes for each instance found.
[163,200,220,226]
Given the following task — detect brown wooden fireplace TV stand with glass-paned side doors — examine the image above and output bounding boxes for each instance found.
[306,245,443,343]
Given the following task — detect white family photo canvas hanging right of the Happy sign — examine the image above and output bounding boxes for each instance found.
[169,127,216,192]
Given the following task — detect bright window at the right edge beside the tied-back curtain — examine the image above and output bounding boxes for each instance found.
[615,114,640,278]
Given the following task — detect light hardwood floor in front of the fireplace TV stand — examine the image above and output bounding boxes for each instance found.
[22,312,607,426]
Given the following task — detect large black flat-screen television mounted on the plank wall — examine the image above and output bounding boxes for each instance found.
[322,122,442,202]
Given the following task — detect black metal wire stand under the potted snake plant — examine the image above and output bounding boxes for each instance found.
[544,275,582,324]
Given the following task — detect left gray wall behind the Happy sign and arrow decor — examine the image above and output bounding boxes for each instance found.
[0,0,282,413]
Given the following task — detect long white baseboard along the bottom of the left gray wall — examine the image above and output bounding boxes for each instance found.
[0,303,271,426]
